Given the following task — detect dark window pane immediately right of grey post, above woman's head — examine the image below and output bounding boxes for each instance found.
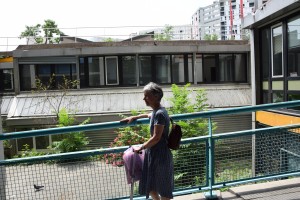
[139,56,152,85]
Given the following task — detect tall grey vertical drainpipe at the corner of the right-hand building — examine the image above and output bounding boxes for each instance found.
[250,29,256,176]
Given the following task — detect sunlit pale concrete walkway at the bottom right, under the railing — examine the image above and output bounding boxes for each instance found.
[174,178,300,200]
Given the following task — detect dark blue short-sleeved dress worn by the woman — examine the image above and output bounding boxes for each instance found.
[139,107,174,199]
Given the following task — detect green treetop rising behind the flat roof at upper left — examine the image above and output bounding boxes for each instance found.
[19,19,64,44]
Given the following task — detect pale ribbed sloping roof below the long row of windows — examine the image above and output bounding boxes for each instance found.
[1,86,251,117]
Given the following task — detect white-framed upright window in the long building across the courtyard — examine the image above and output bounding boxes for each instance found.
[105,56,119,85]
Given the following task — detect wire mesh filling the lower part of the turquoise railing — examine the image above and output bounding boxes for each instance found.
[0,126,300,200]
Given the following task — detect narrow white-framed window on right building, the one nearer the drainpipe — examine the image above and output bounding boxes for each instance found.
[272,25,283,77]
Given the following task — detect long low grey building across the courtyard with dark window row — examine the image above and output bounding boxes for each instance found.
[1,40,251,151]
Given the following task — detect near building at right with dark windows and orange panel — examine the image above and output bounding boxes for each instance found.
[244,0,300,126]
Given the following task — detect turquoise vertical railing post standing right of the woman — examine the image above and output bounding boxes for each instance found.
[204,117,218,199]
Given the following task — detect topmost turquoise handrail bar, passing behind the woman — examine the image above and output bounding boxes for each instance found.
[0,100,300,140]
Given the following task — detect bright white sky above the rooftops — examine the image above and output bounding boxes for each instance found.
[0,0,214,51]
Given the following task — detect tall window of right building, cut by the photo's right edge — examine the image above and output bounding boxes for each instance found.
[287,16,300,77]
